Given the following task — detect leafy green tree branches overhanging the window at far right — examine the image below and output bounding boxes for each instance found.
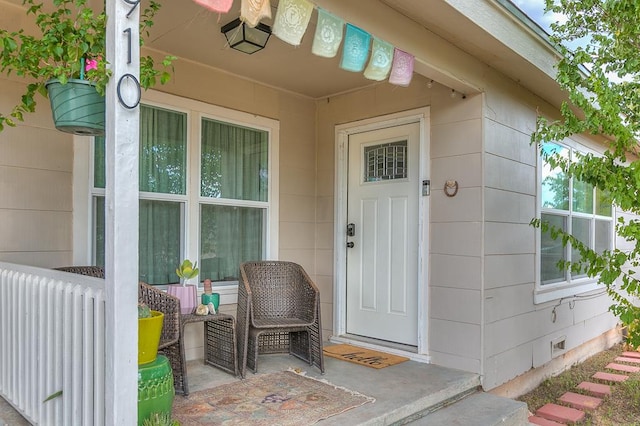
[532,0,640,347]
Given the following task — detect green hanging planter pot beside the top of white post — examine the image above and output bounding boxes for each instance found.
[46,79,105,136]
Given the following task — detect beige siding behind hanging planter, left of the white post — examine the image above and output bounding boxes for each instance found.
[0,77,73,267]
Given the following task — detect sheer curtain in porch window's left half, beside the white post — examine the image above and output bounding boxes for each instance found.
[94,105,187,284]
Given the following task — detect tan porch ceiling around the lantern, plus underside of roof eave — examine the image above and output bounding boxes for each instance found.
[148,0,564,99]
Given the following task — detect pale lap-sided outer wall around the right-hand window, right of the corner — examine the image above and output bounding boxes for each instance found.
[482,83,615,389]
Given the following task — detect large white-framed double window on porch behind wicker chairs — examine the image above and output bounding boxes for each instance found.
[92,101,277,285]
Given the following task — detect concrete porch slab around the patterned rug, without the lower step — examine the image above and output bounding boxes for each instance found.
[185,348,480,426]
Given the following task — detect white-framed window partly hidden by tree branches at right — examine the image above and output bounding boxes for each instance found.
[539,143,613,297]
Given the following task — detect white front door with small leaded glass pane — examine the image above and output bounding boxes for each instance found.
[345,123,421,346]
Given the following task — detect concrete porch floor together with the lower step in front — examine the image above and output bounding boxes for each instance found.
[0,346,528,426]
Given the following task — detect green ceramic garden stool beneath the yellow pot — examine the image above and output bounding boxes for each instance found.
[138,355,175,425]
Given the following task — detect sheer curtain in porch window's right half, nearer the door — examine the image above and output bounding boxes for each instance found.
[200,119,268,281]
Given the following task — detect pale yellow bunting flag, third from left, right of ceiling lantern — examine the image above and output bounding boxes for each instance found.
[273,0,313,46]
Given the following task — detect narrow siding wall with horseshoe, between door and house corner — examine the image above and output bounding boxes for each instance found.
[429,91,483,373]
